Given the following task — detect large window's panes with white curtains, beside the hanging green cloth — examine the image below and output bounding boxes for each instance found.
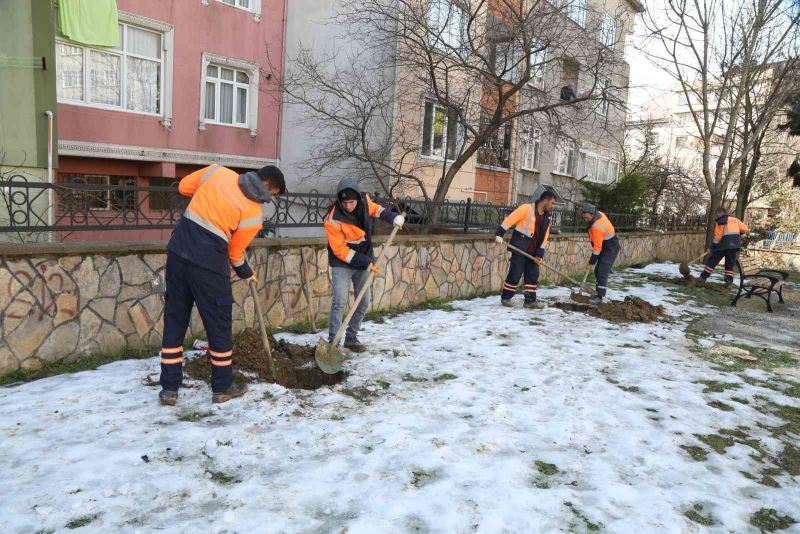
[56,23,165,115]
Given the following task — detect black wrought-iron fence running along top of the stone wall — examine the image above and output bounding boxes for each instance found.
[0,176,704,239]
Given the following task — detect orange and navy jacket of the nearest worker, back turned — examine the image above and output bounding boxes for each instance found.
[167,165,270,278]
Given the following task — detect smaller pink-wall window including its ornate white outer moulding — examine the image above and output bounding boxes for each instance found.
[199,52,259,136]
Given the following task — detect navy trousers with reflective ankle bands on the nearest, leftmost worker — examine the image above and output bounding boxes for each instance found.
[161,252,233,393]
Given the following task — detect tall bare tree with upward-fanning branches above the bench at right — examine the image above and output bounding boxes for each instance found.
[645,0,800,247]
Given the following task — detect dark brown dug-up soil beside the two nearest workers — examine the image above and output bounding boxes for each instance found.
[183,329,345,389]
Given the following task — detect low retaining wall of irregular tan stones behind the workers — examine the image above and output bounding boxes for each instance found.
[0,233,703,375]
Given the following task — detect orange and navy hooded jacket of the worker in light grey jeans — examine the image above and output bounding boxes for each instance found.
[324,178,395,270]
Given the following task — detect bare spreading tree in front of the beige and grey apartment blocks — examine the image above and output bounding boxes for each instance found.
[272,0,631,220]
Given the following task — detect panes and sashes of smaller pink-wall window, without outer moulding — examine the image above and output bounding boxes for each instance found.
[204,65,250,126]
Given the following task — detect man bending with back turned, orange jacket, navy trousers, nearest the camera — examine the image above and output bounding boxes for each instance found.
[159,165,286,406]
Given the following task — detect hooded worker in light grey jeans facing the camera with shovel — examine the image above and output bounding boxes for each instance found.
[324,178,405,352]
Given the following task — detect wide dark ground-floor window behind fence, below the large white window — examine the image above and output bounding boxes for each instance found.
[58,173,137,213]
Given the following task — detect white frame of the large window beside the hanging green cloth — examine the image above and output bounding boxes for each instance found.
[55,11,175,128]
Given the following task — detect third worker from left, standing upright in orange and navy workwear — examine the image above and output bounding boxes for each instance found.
[495,191,556,308]
